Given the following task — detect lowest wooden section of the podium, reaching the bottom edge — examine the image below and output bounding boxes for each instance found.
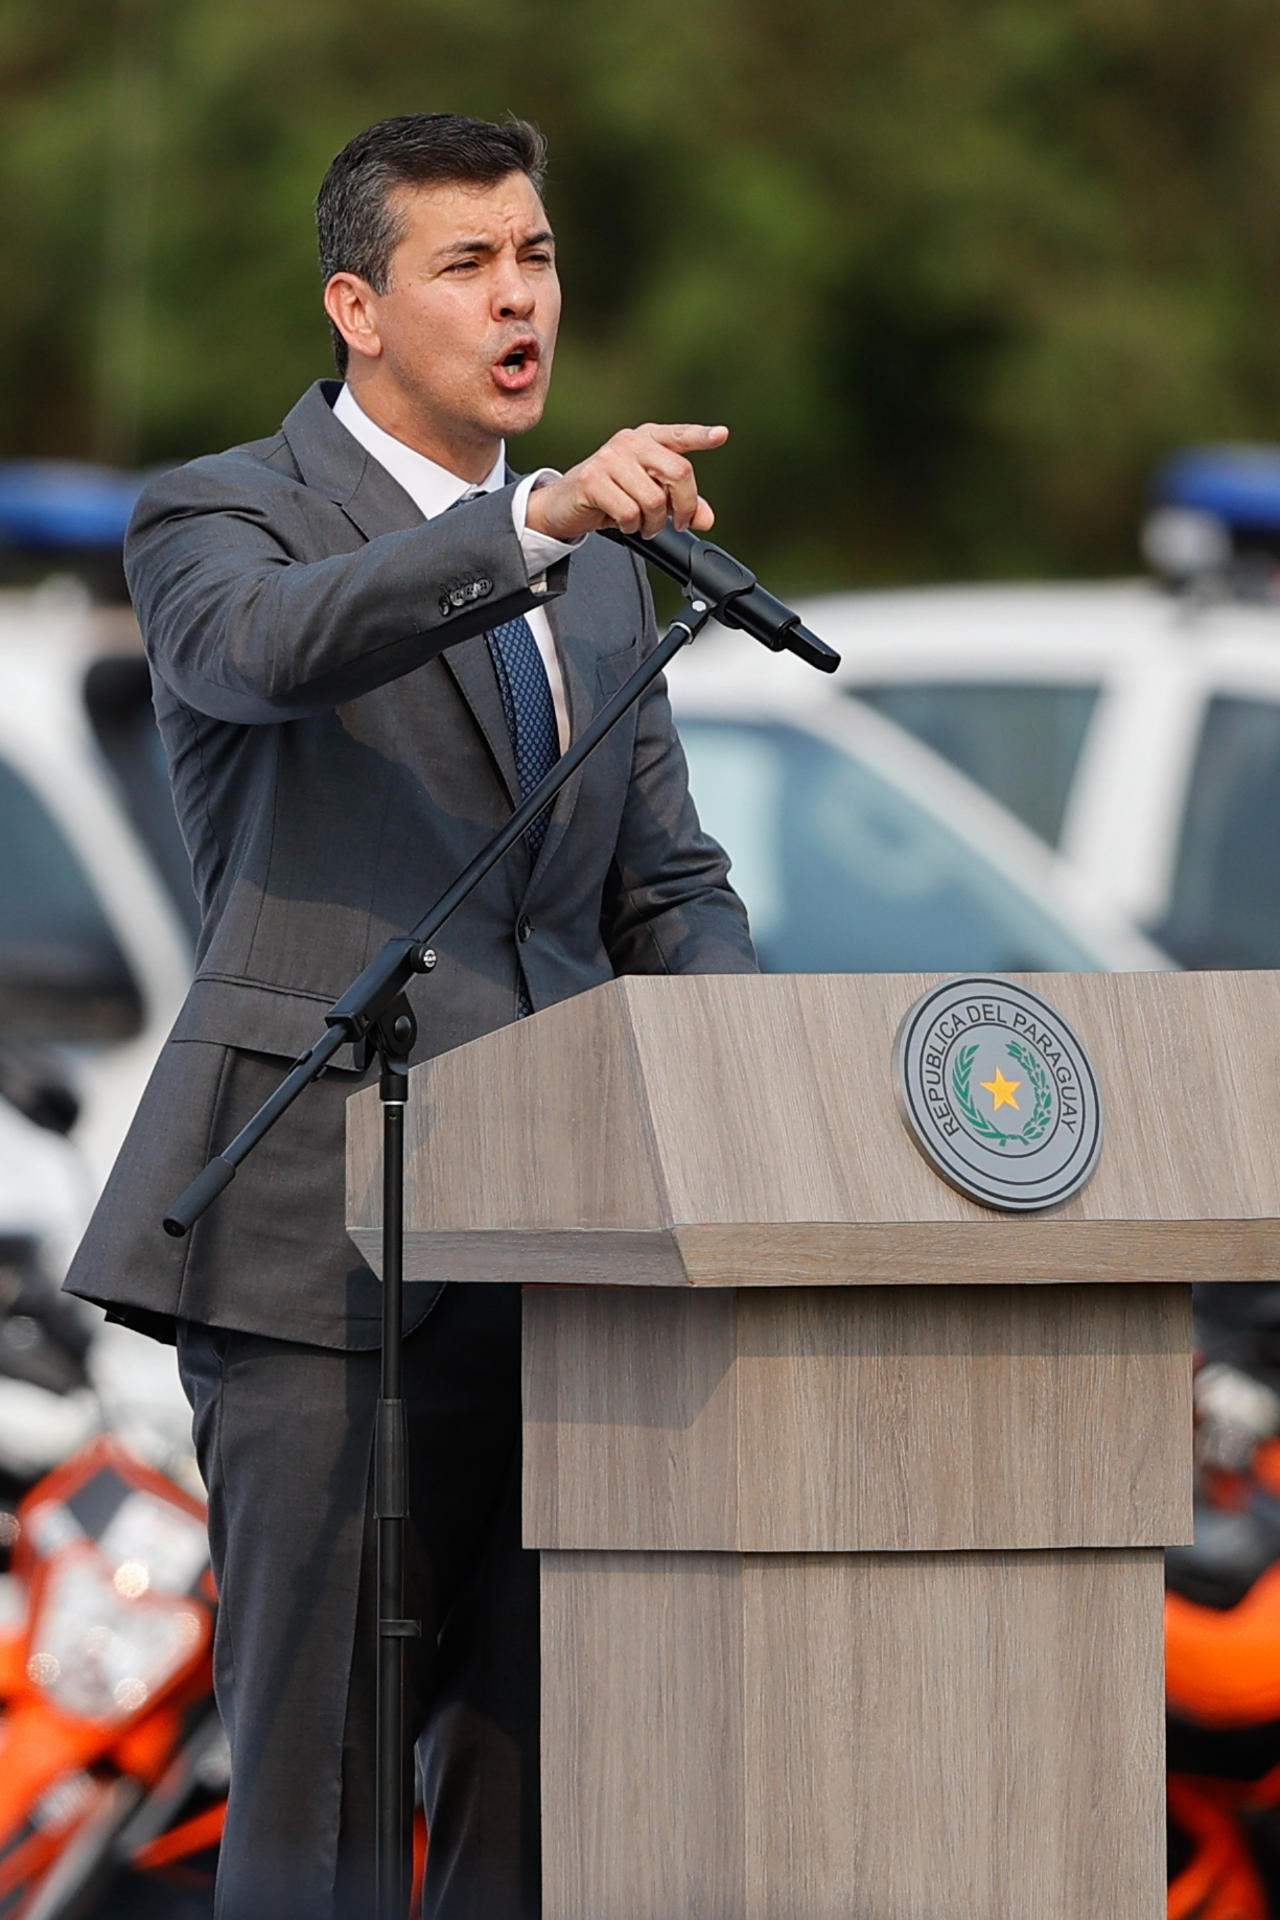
[543,1549,1165,1920]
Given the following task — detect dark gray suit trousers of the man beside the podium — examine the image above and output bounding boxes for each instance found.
[178,1286,539,1920]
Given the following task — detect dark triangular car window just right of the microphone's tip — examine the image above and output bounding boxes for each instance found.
[850,682,1098,847]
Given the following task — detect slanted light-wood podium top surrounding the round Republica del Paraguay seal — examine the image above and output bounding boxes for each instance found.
[347,972,1280,1286]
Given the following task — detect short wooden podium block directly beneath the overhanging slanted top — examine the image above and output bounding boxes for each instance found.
[524,1284,1192,1553]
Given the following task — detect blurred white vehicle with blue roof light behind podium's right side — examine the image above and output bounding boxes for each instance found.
[802,447,1280,968]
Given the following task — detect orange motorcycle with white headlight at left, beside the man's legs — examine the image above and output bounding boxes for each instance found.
[0,1436,226,1920]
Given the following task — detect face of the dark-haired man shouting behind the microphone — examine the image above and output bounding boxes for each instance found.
[330,173,560,480]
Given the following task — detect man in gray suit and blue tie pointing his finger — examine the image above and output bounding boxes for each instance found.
[69,115,754,1920]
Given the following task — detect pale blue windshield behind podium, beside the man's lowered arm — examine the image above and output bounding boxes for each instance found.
[679,718,1098,973]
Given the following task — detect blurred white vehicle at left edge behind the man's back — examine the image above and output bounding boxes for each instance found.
[0,580,192,1231]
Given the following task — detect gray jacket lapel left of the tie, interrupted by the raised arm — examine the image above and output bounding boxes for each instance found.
[284,380,520,806]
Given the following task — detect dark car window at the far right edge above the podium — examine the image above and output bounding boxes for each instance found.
[1155,697,1280,968]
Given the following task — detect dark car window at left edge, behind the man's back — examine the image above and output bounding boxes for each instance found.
[0,758,142,1041]
